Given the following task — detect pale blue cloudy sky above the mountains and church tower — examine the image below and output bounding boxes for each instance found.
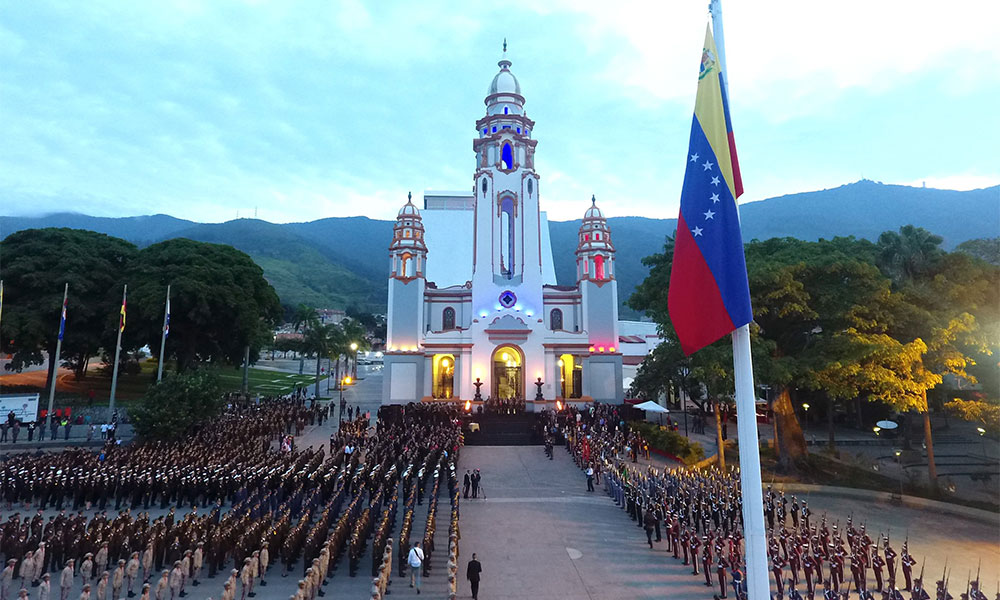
[0,0,1000,222]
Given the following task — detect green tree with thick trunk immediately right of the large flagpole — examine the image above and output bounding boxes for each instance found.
[746,237,888,468]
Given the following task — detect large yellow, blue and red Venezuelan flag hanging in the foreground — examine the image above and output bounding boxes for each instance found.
[667,28,753,354]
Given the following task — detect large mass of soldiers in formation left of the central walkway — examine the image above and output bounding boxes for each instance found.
[0,397,459,600]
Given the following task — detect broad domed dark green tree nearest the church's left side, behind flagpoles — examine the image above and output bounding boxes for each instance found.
[128,238,281,371]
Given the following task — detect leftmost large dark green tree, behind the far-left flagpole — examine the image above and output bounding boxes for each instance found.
[0,228,137,385]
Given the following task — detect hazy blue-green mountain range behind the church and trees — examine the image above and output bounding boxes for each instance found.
[0,180,1000,316]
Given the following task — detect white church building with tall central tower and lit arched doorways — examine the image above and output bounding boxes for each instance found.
[383,45,659,410]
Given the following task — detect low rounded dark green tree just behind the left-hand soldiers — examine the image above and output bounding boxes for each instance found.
[129,369,225,441]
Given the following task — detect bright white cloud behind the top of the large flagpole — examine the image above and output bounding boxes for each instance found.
[540,0,1000,120]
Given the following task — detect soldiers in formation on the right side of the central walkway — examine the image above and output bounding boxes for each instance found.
[550,405,984,600]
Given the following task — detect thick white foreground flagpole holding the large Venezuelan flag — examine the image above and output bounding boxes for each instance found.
[709,0,771,600]
